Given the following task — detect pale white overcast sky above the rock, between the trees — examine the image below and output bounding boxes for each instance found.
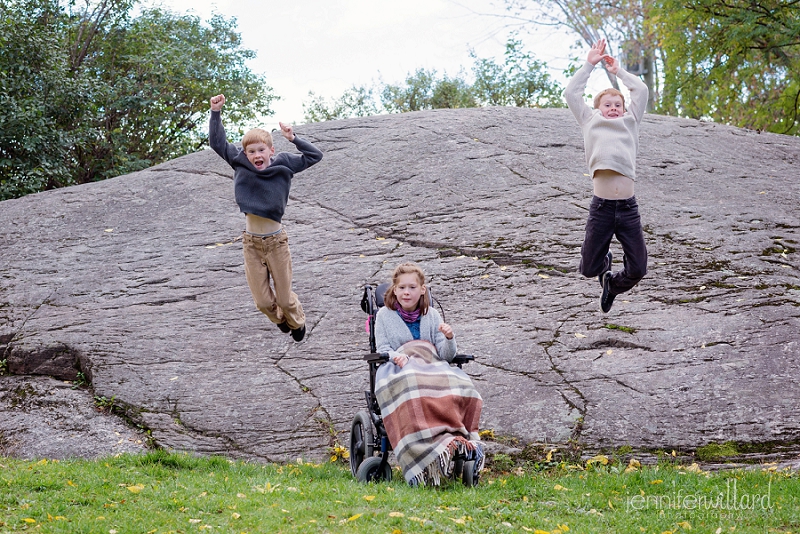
[150,0,599,128]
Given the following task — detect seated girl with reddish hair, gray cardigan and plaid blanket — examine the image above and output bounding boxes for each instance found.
[375,263,484,485]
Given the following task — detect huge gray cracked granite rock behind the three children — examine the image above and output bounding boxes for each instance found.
[0,108,800,460]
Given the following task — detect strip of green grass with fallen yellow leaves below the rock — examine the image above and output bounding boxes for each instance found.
[0,451,800,534]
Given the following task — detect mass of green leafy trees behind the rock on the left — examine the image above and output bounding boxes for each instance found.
[0,0,275,199]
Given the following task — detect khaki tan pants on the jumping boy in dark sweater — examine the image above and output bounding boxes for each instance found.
[242,229,306,330]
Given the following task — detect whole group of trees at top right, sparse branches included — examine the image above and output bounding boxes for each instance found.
[505,0,800,135]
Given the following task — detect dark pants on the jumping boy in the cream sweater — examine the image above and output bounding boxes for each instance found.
[579,196,647,295]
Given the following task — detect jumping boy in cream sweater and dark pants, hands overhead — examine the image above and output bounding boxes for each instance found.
[564,39,647,313]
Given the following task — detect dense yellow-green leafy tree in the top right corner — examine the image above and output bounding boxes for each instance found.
[656,0,800,135]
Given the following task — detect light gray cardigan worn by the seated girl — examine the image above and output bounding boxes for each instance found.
[375,307,457,362]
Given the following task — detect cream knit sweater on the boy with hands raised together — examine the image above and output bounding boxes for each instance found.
[564,61,647,181]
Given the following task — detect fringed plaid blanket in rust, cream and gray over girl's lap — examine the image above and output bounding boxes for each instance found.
[375,340,483,485]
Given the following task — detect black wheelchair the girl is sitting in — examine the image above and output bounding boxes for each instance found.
[350,283,478,486]
